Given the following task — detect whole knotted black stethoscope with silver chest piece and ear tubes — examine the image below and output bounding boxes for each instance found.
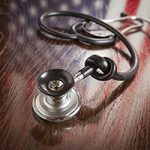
[33,11,150,122]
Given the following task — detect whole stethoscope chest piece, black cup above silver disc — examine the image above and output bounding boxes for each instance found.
[33,69,81,122]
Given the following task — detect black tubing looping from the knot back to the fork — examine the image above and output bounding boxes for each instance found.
[39,11,139,80]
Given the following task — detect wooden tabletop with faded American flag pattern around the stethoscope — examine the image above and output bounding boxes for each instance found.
[0,0,150,150]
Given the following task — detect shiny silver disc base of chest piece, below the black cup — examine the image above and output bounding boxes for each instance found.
[32,88,81,122]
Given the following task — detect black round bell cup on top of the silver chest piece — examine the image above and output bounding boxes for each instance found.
[37,69,75,96]
